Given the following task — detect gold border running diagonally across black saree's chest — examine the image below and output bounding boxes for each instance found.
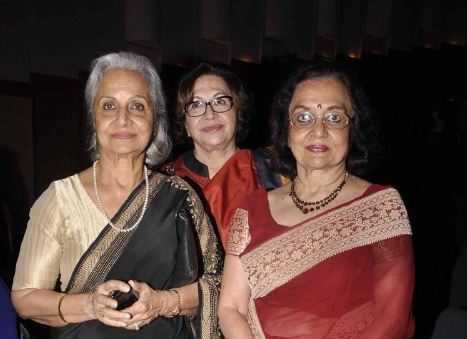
[67,174,165,293]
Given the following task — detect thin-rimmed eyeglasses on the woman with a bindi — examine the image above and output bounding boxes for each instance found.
[289,112,350,129]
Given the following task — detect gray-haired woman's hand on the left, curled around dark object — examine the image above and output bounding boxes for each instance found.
[86,280,131,327]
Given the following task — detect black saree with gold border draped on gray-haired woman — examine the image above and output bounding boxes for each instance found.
[52,173,222,339]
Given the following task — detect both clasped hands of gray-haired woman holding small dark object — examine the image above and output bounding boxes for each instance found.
[86,280,174,330]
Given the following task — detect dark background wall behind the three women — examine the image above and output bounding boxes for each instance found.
[0,0,467,338]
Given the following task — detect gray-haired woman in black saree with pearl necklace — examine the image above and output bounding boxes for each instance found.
[12,52,222,339]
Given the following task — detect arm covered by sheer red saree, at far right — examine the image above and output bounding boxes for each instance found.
[359,235,414,339]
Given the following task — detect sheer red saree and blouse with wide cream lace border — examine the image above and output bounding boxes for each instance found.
[227,185,414,339]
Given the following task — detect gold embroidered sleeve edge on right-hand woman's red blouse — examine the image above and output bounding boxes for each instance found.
[226,208,251,255]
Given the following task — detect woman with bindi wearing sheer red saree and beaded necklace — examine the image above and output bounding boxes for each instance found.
[219,64,414,339]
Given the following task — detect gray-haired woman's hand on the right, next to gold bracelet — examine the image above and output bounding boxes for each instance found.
[123,280,171,330]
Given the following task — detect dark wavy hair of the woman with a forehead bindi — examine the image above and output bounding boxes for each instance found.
[270,62,381,178]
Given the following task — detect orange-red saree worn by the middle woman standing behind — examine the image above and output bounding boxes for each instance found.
[173,150,278,248]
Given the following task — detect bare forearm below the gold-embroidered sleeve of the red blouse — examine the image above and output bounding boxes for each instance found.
[219,254,253,339]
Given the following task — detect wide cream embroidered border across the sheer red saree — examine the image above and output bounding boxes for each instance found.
[240,188,412,299]
